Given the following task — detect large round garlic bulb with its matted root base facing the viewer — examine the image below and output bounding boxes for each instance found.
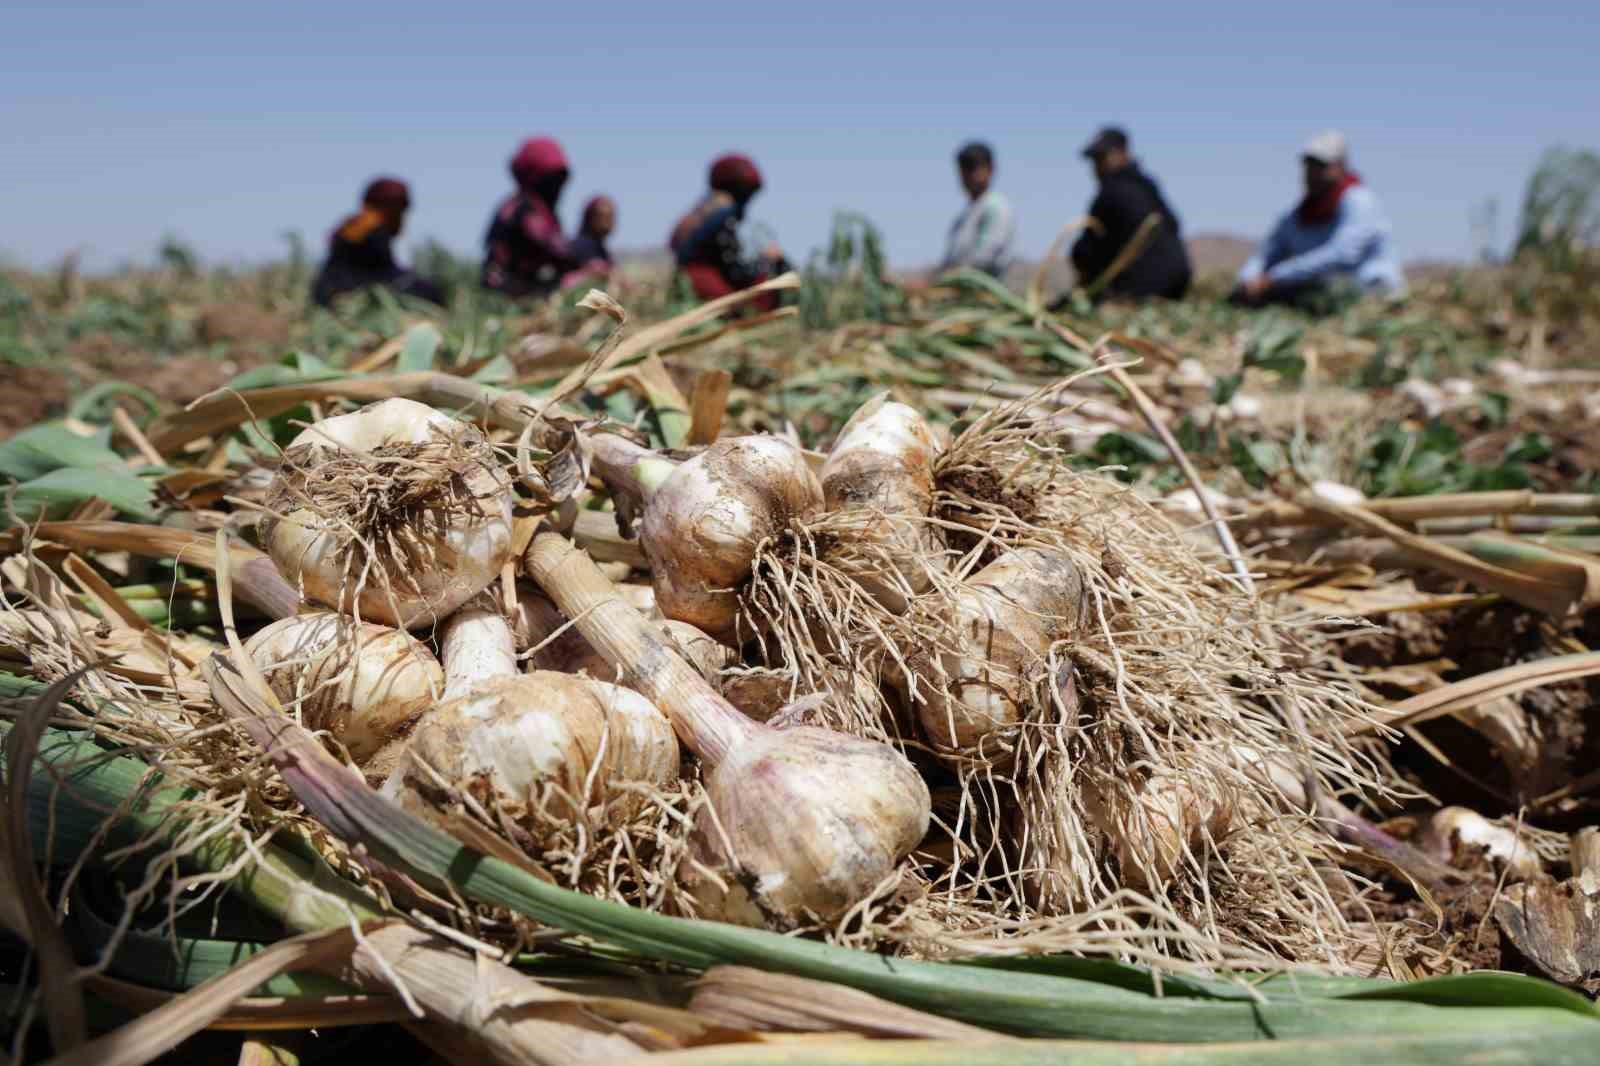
[261,399,512,629]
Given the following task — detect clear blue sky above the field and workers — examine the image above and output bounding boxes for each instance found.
[0,0,1600,266]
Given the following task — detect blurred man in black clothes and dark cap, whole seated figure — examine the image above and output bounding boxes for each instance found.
[1072,126,1192,299]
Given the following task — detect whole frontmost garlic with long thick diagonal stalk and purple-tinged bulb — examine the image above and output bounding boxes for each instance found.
[525,533,931,927]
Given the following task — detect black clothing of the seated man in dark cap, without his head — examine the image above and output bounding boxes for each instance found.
[1072,163,1190,299]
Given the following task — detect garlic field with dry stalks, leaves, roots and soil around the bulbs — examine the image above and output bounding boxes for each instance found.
[0,192,1600,1063]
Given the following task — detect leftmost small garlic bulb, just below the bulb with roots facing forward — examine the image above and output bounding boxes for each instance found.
[245,611,445,767]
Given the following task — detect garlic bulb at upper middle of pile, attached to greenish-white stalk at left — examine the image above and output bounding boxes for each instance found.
[638,437,822,637]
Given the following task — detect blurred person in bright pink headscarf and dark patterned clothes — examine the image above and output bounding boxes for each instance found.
[482,138,582,296]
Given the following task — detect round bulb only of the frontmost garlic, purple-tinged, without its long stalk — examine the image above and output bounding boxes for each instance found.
[682,725,930,928]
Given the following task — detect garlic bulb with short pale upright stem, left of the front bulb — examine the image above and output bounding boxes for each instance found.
[393,607,678,839]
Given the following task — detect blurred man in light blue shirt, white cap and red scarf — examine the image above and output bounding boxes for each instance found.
[1234,130,1405,304]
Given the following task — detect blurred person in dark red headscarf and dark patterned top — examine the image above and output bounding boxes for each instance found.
[669,155,789,311]
